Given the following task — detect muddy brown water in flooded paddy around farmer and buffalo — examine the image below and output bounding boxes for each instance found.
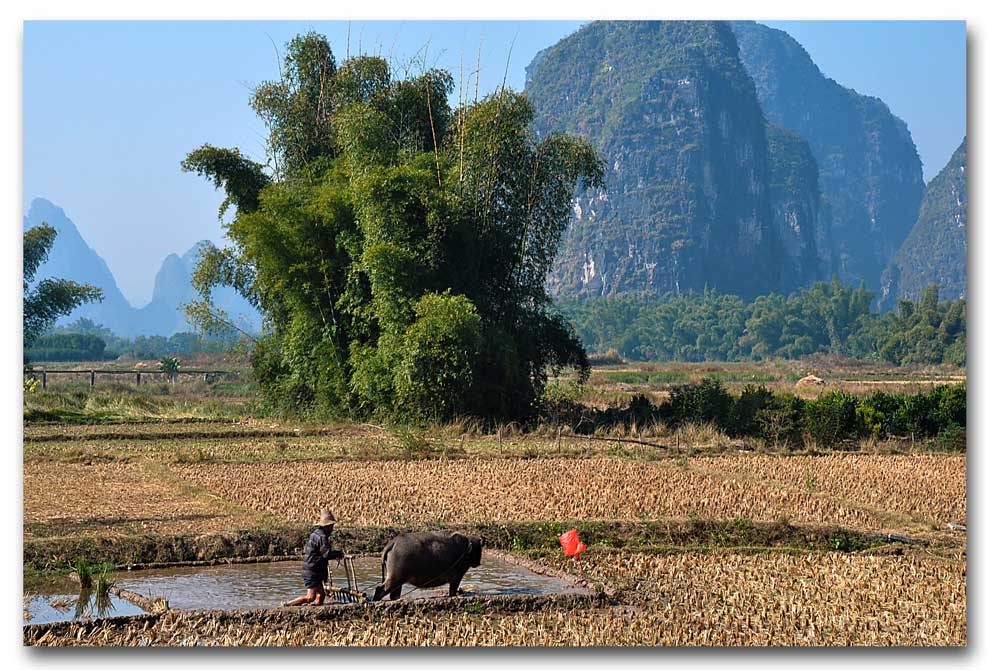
[107,556,587,610]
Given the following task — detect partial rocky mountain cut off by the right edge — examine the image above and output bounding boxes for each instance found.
[880,138,967,308]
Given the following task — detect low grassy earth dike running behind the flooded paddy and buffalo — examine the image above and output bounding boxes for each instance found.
[24,519,889,573]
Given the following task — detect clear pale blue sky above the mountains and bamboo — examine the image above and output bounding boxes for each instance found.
[23,21,966,307]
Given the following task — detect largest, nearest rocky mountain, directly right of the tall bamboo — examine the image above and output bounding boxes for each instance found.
[526,21,820,297]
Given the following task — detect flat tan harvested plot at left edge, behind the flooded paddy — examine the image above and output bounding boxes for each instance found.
[24,462,258,538]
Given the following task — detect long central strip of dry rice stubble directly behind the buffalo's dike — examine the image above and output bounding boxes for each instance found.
[172,457,908,530]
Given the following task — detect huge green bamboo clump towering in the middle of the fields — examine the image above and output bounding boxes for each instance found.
[183,33,603,420]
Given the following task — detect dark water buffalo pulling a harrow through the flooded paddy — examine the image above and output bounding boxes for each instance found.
[372,533,482,600]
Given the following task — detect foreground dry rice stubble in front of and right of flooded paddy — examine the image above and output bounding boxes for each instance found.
[27,553,966,646]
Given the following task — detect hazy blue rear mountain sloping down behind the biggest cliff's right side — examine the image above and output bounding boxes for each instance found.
[733,22,924,290]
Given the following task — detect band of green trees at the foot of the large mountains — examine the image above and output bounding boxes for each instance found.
[557,280,966,365]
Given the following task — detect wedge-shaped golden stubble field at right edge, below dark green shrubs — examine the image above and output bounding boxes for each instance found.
[693,454,966,526]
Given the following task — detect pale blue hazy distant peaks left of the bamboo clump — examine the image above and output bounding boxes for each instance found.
[24,198,261,337]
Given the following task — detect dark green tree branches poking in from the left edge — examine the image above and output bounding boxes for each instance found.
[24,224,103,349]
